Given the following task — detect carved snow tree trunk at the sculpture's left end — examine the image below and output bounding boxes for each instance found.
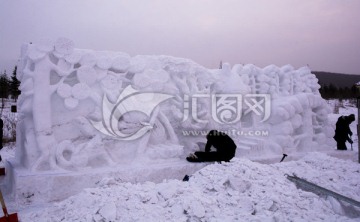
[28,39,80,170]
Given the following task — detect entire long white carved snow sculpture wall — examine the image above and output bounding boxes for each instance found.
[16,38,331,170]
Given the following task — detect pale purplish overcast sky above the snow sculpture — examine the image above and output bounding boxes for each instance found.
[0,0,360,74]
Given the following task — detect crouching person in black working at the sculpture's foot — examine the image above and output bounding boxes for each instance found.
[186,130,236,162]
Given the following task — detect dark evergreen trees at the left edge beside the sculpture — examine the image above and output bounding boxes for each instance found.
[0,66,21,105]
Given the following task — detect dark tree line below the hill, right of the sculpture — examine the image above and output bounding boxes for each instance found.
[319,83,360,99]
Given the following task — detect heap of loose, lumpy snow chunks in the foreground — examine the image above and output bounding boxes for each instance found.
[19,153,360,222]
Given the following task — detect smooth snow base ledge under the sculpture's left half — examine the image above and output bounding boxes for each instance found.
[4,160,206,205]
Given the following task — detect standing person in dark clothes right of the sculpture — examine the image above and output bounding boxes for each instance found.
[334,114,355,150]
